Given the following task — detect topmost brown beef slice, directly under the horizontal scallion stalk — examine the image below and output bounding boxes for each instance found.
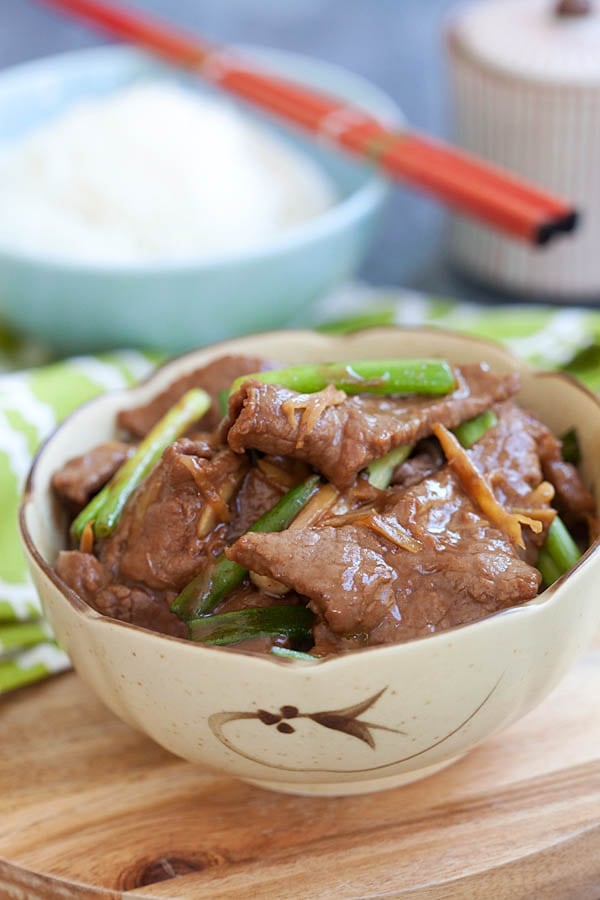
[223,364,518,488]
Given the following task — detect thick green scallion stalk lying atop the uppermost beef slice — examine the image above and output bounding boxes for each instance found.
[231,359,456,395]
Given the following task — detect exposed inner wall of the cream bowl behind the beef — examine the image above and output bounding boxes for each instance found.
[24,328,600,616]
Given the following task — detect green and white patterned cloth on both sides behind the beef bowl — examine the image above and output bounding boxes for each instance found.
[0,286,600,694]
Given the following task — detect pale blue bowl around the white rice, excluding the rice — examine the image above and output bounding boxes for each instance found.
[0,47,399,352]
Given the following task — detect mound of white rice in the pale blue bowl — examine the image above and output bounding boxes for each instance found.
[0,82,335,264]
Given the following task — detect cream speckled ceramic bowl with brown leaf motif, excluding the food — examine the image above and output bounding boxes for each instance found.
[20,328,600,795]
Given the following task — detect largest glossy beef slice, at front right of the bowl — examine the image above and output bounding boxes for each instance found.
[228,496,540,644]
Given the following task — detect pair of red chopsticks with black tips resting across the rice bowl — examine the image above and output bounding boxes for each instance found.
[38,0,577,245]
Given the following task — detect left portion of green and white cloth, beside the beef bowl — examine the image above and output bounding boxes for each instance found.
[0,339,156,694]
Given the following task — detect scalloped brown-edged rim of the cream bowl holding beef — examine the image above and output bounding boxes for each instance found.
[19,326,600,677]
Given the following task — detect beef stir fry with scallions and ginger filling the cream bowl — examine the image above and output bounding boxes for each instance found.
[53,357,596,657]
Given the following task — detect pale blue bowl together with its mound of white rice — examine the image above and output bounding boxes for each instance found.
[0,47,399,352]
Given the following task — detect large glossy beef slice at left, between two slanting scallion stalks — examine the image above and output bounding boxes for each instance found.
[99,439,312,595]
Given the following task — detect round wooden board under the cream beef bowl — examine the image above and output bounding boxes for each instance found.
[0,638,600,900]
